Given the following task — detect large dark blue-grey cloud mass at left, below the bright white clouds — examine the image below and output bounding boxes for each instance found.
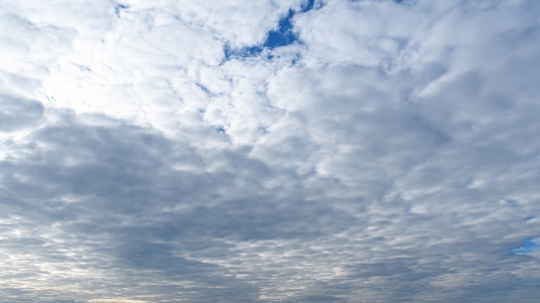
[2,110,358,302]
